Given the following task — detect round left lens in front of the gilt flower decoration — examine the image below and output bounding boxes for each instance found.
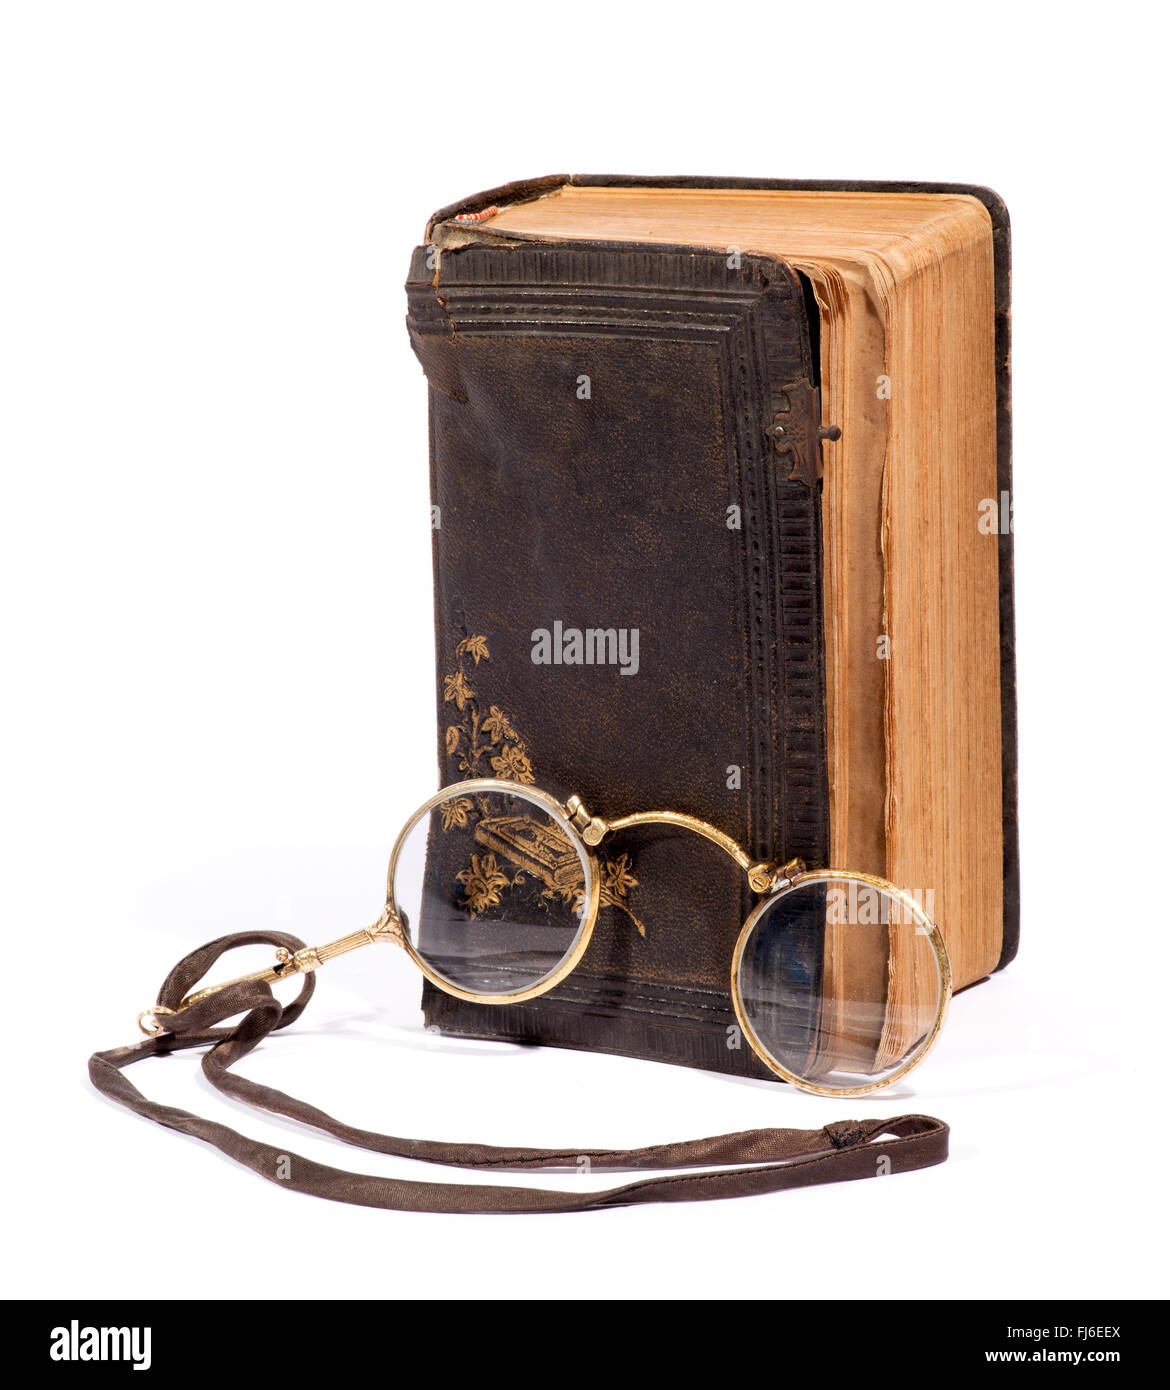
[390,781,596,997]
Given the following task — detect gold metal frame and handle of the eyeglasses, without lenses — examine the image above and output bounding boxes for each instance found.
[138,777,952,1095]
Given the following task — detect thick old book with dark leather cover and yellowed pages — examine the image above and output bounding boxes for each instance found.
[407,177,1019,1076]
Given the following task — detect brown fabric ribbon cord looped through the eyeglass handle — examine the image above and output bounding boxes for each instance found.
[89,931,949,1212]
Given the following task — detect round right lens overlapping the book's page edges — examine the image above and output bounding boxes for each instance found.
[735,873,945,1091]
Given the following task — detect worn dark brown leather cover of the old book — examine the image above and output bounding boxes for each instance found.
[407,177,1019,1077]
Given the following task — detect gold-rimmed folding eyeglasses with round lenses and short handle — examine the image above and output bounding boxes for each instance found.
[139,777,950,1095]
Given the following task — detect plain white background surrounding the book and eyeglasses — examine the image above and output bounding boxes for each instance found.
[0,0,1167,1298]
